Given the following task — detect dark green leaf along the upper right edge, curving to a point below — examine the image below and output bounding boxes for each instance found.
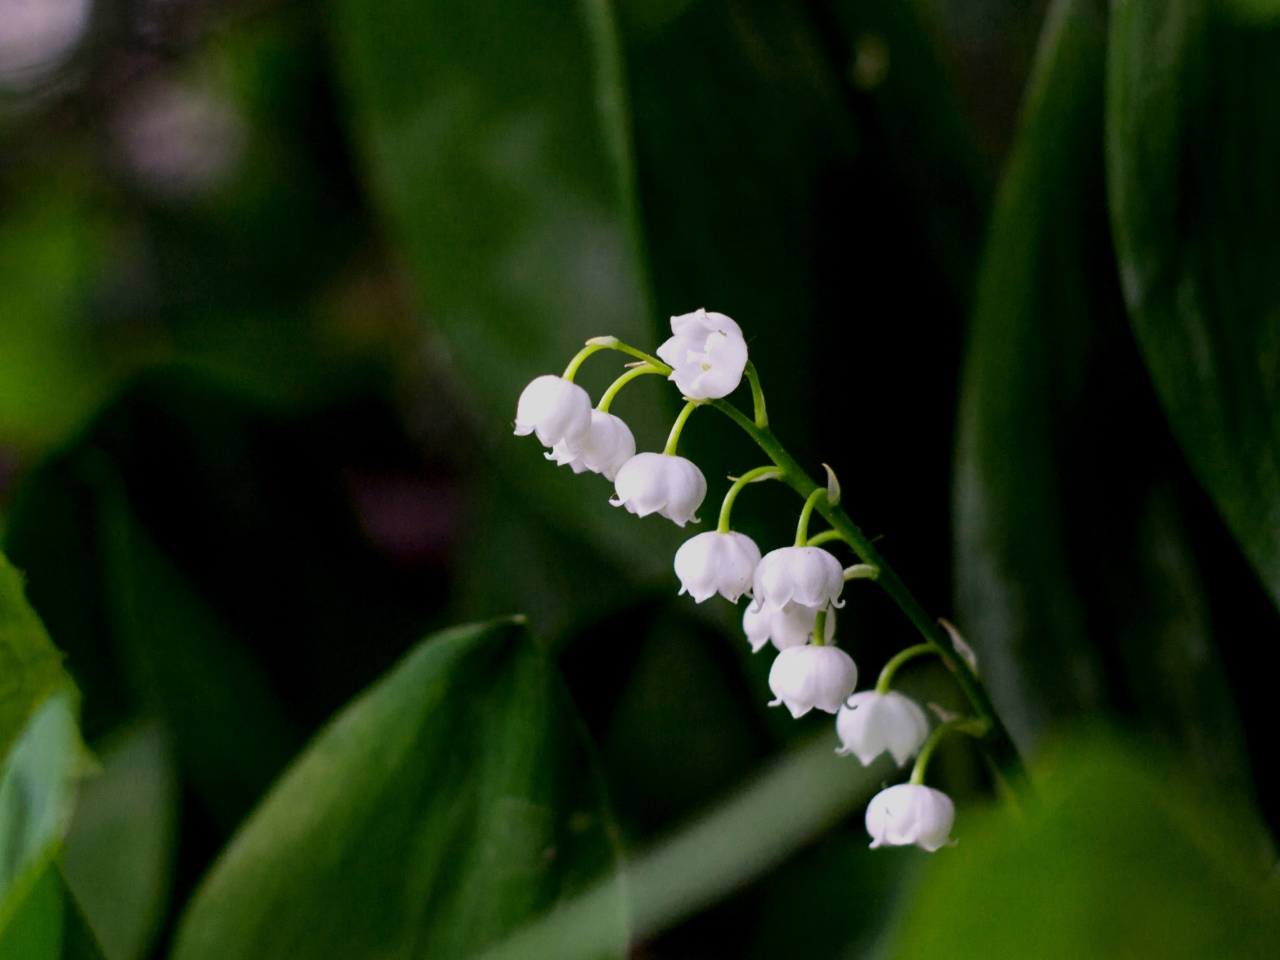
[1106,0,1280,604]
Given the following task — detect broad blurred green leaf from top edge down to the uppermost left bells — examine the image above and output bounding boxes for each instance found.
[334,0,653,429]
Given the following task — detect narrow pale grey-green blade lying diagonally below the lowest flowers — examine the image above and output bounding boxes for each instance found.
[473,733,892,960]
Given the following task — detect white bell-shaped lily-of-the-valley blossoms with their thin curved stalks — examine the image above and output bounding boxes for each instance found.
[516,310,963,851]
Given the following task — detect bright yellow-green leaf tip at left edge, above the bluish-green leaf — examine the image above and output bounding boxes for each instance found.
[0,554,68,758]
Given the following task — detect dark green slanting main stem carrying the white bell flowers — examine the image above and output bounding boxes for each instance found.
[712,399,1028,788]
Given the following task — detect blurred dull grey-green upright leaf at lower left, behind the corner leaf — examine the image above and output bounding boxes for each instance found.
[63,722,178,960]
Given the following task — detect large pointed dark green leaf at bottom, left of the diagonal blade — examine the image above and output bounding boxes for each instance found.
[174,621,626,960]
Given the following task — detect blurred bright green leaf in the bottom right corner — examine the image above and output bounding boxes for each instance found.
[891,741,1280,960]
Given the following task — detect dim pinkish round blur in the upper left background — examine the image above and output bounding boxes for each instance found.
[113,78,247,200]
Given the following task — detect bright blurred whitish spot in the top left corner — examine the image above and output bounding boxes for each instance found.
[0,0,91,90]
